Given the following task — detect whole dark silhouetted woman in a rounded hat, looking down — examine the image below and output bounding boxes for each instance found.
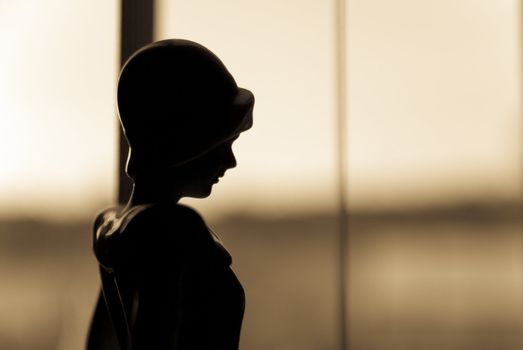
[88,39,254,350]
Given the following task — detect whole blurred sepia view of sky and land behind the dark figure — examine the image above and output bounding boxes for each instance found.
[0,0,523,350]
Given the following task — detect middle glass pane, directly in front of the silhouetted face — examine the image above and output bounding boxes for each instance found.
[156,0,337,350]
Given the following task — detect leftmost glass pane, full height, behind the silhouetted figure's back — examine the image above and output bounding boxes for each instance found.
[0,0,117,350]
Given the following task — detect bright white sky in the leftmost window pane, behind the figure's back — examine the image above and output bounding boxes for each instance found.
[0,0,117,217]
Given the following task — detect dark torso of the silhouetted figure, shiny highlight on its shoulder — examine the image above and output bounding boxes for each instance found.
[95,205,244,350]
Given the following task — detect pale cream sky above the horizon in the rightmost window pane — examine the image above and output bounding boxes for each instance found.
[348,0,523,206]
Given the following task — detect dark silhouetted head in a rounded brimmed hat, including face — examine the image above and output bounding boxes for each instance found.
[117,39,254,197]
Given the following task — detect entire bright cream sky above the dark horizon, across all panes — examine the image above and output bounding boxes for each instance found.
[0,0,523,216]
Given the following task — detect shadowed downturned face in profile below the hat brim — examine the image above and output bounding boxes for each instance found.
[170,136,238,198]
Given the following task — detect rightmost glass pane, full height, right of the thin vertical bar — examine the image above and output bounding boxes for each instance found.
[348,0,523,350]
